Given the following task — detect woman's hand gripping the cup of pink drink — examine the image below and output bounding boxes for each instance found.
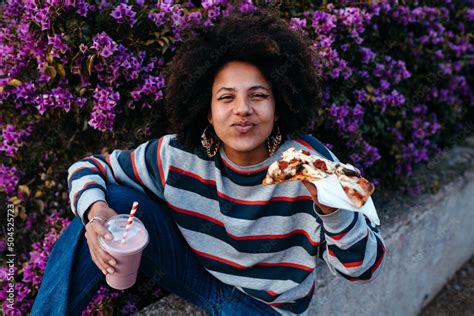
[85,201,117,274]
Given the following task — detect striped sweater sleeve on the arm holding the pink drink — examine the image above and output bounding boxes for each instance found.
[67,136,167,223]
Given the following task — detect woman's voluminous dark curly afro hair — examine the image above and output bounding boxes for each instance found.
[164,8,321,150]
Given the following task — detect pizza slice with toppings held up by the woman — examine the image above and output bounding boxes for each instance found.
[262,147,375,208]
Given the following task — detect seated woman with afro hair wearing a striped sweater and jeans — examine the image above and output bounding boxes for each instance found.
[33,7,385,315]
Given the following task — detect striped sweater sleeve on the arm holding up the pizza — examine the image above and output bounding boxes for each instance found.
[313,147,387,282]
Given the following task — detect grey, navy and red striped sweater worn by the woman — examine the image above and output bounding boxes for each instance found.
[68,134,385,315]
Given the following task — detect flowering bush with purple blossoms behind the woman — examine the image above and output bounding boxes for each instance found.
[0,0,474,314]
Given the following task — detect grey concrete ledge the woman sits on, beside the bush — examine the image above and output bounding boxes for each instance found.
[139,137,474,316]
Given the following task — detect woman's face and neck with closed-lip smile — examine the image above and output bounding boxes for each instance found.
[208,61,275,165]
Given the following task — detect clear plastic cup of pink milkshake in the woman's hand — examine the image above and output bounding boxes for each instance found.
[99,214,149,290]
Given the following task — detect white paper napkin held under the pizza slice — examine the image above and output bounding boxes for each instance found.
[311,174,380,226]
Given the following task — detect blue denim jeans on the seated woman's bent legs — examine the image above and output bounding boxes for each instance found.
[31,185,278,316]
